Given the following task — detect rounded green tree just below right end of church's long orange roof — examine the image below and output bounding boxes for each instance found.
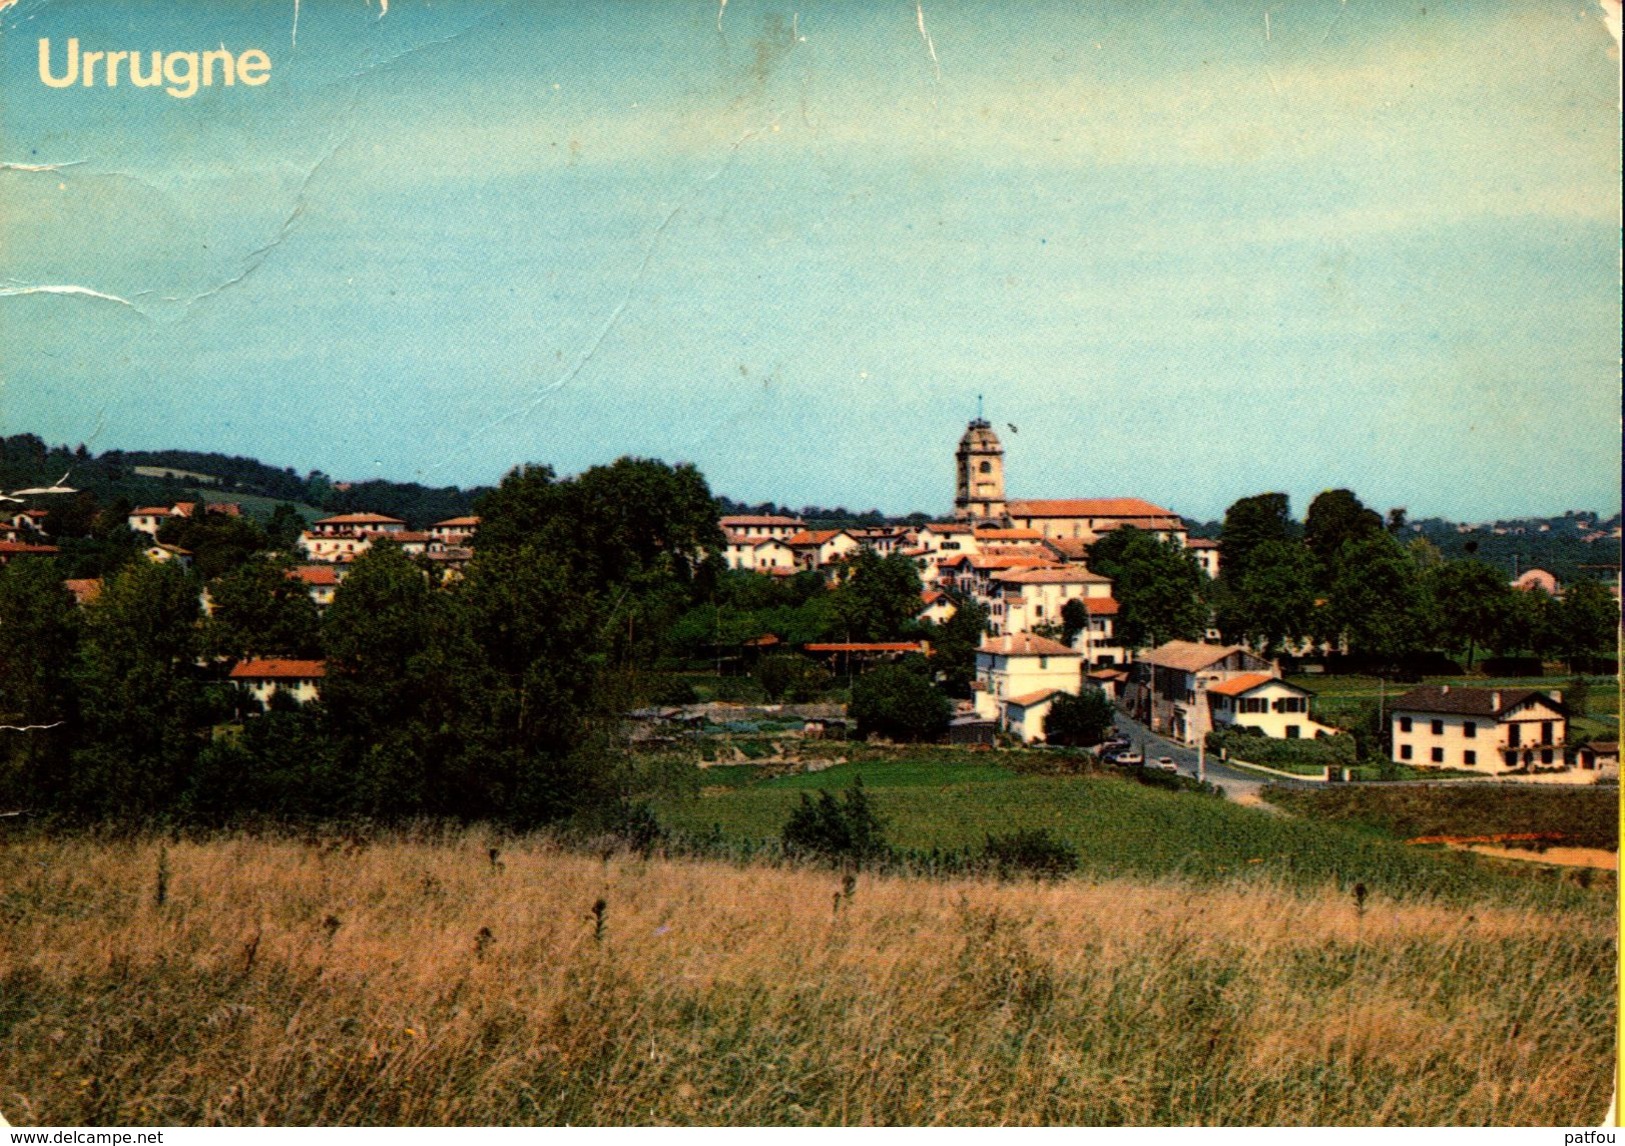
[1089,527,1207,649]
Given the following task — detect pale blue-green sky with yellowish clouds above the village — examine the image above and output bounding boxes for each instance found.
[0,0,1620,520]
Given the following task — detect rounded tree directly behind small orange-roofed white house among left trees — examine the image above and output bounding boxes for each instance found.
[203,561,322,660]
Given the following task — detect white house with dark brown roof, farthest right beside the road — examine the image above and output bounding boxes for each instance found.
[1388,684,1568,774]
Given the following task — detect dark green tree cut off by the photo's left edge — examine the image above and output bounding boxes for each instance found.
[0,559,80,810]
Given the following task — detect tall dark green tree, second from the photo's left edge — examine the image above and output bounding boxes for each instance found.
[70,562,206,823]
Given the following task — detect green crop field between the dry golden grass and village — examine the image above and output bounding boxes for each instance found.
[657,749,1605,902]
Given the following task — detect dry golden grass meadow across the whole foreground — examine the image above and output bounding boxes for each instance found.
[0,834,1614,1125]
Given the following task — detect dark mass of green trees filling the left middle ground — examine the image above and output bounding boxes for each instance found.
[0,458,980,826]
